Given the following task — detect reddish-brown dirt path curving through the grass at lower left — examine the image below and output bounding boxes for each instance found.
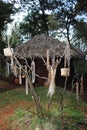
[0,102,33,130]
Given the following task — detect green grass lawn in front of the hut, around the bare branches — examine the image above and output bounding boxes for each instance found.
[0,87,87,130]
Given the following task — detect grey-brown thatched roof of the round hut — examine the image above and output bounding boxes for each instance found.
[15,34,84,58]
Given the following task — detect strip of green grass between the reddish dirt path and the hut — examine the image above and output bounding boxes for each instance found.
[0,88,32,107]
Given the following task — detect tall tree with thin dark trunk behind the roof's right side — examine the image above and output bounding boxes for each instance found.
[50,0,87,44]
